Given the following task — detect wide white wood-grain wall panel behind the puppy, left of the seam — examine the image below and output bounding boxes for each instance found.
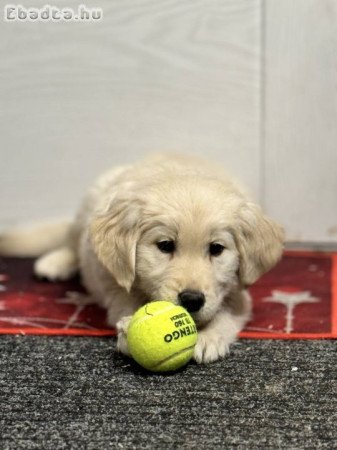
[0,0,261,225]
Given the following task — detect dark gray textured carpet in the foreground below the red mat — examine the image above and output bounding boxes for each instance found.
[0,336,337,450]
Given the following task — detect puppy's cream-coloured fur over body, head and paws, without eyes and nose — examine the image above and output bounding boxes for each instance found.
[0,155,283,362]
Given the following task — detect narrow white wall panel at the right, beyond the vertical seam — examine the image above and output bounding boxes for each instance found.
[262,0,337,242]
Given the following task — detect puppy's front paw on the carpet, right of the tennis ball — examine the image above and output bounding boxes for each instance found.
[193,330,230,364]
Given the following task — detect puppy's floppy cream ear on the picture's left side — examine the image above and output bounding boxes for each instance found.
[90,200,140,292]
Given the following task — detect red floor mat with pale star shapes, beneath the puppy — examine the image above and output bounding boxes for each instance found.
[0,252,337,339]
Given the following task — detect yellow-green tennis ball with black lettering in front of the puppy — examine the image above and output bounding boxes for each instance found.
[127,301,197,372]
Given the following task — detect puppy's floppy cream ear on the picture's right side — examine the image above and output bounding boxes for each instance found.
[233,203,284,286]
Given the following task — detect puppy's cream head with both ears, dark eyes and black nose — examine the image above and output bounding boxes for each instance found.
[91,177,283,325]
